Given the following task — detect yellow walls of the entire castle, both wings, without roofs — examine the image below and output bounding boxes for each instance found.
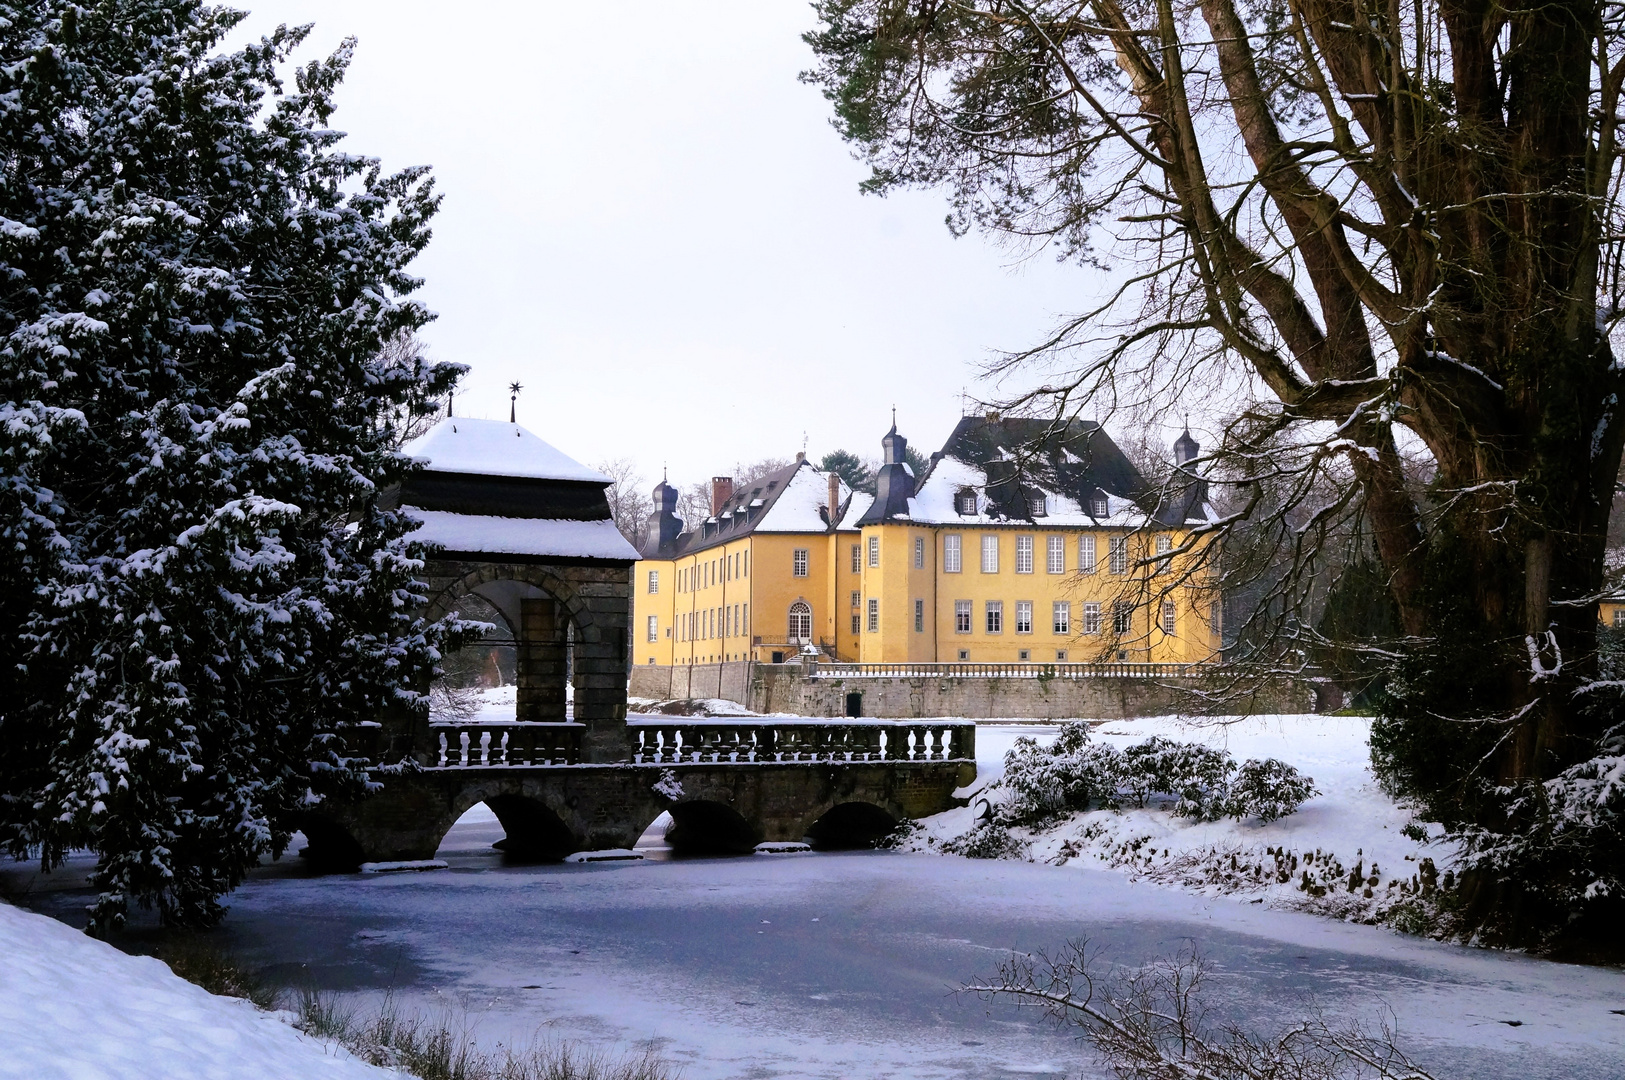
[634,523,1222,664]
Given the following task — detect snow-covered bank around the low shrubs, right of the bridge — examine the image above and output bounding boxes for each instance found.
[915,715,1451,919]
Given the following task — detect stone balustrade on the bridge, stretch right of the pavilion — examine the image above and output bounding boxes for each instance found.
[627,716,977,763]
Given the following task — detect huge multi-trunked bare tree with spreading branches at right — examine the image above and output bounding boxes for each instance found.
[806,0,1625,940]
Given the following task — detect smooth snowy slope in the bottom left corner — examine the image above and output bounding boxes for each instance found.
[0,903,401,1080]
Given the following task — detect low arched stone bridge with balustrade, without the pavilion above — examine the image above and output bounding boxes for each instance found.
[304,718,977,869]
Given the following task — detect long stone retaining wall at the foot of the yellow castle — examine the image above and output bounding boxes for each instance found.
[632,663,1313,719]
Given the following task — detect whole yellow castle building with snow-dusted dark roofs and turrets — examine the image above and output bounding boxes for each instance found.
[634,416,1222,664]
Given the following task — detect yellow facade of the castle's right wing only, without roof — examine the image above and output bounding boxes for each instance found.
[858,523,1222,664]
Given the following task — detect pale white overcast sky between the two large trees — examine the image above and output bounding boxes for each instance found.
[237,0,1089,482]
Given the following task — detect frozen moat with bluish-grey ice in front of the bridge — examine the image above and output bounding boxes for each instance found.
[12,809,1625,1080]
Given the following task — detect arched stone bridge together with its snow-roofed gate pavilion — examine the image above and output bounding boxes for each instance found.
[301,416,977,869]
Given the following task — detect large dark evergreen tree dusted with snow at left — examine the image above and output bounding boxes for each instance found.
[0,0,462,924]
